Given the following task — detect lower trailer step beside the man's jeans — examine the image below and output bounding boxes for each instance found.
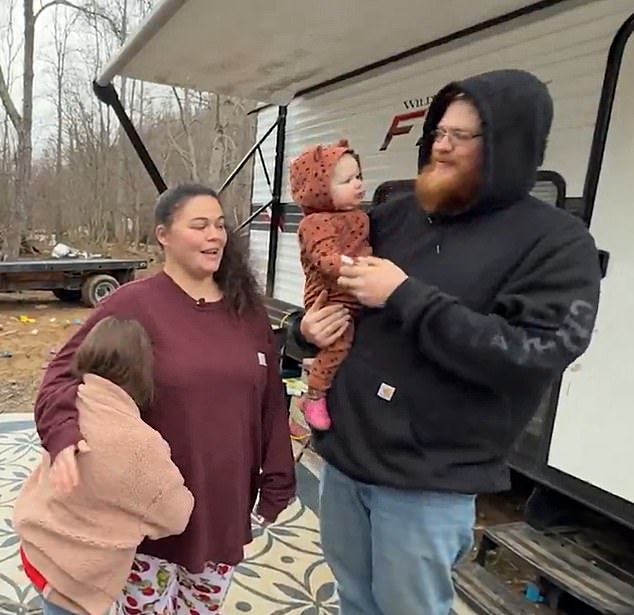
[453,562,544,615]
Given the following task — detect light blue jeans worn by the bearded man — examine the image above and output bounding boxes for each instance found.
[320,464,475,615]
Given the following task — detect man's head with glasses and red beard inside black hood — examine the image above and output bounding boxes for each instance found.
[416,70,553,215]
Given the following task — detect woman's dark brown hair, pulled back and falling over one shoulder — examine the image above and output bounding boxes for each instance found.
[154,184,262,315]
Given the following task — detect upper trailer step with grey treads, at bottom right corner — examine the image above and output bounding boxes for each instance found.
[479,522,634,615]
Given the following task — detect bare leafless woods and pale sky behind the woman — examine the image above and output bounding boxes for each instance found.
[0,0,255,259]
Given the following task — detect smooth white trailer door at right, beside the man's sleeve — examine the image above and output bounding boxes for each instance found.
[548,22,634,503]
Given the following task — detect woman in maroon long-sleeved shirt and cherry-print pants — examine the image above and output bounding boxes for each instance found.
[35,185,295,615]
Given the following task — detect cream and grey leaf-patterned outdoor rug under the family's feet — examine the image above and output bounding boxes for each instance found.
[0,414,338,615]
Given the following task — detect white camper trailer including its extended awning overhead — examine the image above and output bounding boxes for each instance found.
[95,0,634,613]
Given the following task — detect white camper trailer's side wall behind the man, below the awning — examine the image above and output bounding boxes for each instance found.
[250,0,634,527]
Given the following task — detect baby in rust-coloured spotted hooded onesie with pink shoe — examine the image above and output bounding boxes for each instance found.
[290,140,371,430]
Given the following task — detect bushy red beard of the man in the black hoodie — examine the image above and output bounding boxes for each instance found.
[416,161,482,214]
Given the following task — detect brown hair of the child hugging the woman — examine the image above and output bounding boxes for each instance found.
[70,316,154,407]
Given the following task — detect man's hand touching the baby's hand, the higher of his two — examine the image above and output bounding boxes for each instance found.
[337,256,407,307]
